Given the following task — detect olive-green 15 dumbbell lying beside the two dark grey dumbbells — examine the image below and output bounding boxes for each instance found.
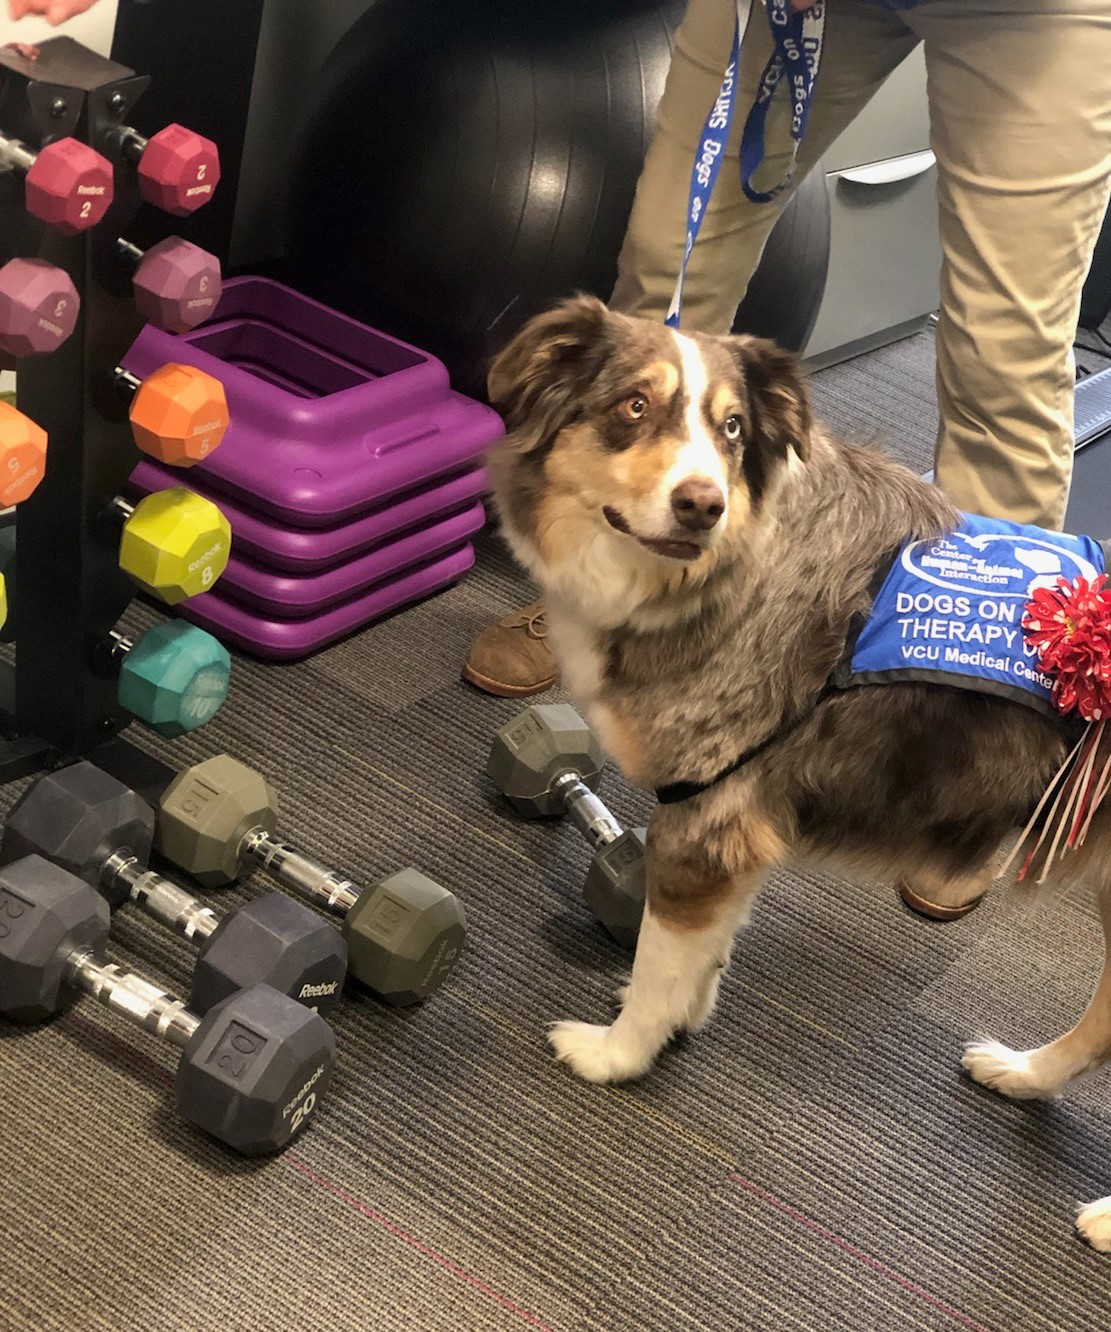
[143,754,466,1007]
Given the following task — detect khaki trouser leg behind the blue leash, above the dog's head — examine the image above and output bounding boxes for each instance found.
[610,0,918,333]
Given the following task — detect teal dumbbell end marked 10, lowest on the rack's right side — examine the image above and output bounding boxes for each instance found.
[119,619,232,737]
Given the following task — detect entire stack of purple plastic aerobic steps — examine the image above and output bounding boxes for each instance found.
[124,277,502,659]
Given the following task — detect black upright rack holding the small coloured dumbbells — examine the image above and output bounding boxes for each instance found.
[0,37,175,782]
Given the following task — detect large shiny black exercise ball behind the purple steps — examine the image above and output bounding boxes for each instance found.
[290,0,829,392]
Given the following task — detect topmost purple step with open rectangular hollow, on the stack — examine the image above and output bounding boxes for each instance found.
[124,277,504,529]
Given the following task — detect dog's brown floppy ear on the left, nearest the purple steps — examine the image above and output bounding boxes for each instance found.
[486,296,609,450]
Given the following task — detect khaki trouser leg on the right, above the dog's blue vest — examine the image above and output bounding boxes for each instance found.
[906,0,1111,537]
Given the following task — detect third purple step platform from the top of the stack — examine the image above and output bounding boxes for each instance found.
[217,501,486,619]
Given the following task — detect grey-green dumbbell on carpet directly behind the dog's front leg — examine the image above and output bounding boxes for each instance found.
[486,703,645,948]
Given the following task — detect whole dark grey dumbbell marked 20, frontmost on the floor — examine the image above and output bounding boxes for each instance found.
[0,855,336,1156]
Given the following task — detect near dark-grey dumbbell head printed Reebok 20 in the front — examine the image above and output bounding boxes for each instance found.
[176,986,336,1156]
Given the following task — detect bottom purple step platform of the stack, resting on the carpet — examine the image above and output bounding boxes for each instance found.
[177,542,474,661]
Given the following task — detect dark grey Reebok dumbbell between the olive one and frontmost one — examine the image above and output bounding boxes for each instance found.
[0,763,348,1014]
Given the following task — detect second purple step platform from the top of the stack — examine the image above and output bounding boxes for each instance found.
[128,458,486,574]
